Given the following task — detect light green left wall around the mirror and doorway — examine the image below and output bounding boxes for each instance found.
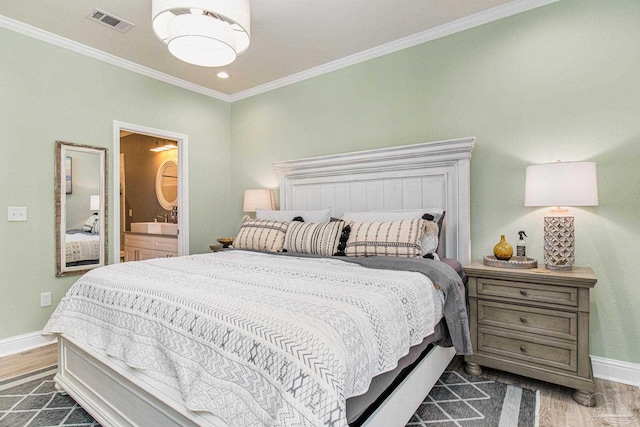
[0,29,230,339]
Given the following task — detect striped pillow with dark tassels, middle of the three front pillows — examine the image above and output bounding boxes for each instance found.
[284,221,345,256]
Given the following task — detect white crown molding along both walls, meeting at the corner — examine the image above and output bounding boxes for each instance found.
[0,0,559,103]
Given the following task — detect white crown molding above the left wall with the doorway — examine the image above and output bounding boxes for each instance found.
[0,15,231,102]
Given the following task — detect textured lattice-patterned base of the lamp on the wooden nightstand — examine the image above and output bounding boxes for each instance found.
[544,211,575,270]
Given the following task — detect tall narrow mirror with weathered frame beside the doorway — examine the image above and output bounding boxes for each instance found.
[55,141,108,276]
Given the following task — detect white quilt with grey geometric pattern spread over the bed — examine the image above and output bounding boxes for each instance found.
[45,251,442,427]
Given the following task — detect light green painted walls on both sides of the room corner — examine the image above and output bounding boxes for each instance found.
[0,0,640,363]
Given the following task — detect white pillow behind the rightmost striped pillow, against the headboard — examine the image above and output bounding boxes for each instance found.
[342,208,445,255]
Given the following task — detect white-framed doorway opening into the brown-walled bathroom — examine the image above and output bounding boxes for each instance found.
[112,121,189,262]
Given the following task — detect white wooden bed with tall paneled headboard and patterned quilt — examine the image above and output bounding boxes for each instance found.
[46,138,475,426]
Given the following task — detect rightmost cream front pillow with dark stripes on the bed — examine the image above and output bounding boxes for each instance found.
[345,218,430,257]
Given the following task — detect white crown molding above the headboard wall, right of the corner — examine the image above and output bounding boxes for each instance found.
[230,0,560,102]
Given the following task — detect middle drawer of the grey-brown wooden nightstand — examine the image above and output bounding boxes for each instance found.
[478,300,578,340]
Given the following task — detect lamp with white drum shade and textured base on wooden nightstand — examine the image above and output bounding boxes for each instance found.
[524,161,598,270]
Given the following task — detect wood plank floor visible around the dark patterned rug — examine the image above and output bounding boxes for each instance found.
[0,344,640,427]
